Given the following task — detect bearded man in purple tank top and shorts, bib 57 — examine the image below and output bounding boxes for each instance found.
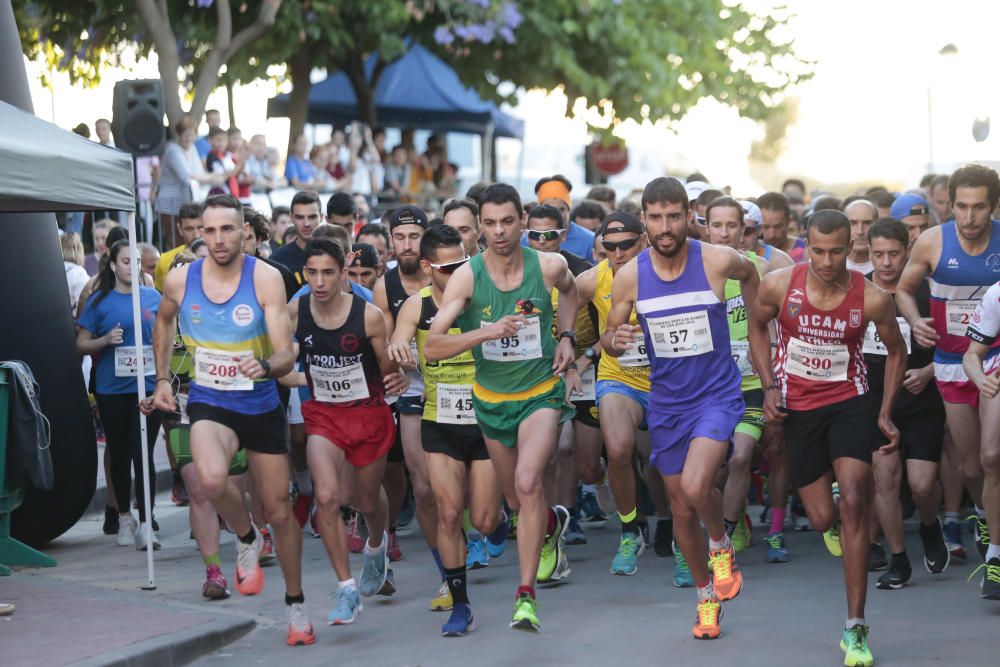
[601,178,770,639]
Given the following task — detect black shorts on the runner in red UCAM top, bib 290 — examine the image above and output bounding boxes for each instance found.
[783,394,885,488]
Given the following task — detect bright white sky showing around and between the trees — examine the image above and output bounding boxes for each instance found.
[21,0,1000,195]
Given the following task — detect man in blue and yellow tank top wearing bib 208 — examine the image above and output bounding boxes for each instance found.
[153,195,316,645]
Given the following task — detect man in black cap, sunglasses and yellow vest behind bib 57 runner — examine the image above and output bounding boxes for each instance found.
[577,212,652,585]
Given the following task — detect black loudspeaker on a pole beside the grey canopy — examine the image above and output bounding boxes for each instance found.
[111,79,167,157]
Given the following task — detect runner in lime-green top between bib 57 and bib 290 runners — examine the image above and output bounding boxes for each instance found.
[705,197,789,563]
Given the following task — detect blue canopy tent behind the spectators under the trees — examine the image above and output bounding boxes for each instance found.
[267,44,524,180]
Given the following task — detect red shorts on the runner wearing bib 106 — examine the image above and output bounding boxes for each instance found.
[302,400,396,468]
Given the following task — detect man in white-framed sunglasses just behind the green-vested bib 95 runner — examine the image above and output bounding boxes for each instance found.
[525,204,604,558]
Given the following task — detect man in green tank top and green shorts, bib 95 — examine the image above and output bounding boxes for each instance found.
[424,183,580,631]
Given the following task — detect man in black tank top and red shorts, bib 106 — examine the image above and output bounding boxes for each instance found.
[288,239,406,625]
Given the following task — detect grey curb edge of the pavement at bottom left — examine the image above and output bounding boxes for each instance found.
[70,616,257,667]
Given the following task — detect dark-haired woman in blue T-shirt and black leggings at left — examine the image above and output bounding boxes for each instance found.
[76,241,160,549]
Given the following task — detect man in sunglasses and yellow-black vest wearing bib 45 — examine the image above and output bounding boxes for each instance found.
[389,225,500,637]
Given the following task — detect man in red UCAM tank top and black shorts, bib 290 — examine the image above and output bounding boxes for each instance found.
[750,210,906,667]
